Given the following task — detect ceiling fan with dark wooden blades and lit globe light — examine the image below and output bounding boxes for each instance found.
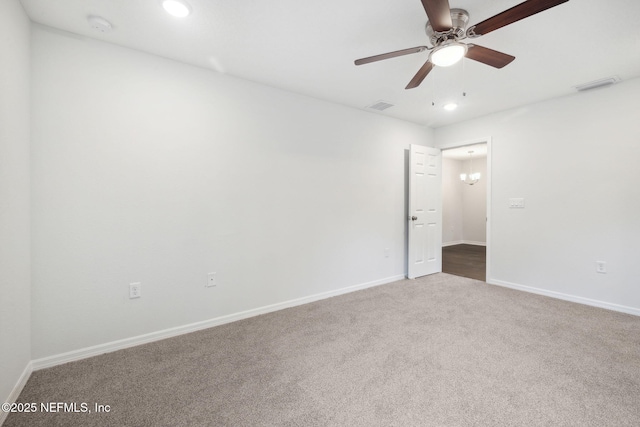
[355,0,569,89]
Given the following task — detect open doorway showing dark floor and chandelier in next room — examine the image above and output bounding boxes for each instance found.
[442,142,490,281]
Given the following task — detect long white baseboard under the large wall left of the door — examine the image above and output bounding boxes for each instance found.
[31,275,405,370]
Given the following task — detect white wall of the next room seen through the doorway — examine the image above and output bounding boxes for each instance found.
[442,157,487,246]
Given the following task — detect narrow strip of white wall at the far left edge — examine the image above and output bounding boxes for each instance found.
[0,0,31,410]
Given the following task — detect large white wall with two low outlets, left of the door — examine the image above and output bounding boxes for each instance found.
[32,26,433,359]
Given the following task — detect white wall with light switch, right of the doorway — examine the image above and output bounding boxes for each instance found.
[436,79,640,314]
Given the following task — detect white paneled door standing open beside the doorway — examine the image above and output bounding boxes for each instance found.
[407,145,442,279]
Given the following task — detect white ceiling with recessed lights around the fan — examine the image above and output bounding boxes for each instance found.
[21,0,640,127]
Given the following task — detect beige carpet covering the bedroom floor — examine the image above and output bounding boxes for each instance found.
[5,274,640,427]
